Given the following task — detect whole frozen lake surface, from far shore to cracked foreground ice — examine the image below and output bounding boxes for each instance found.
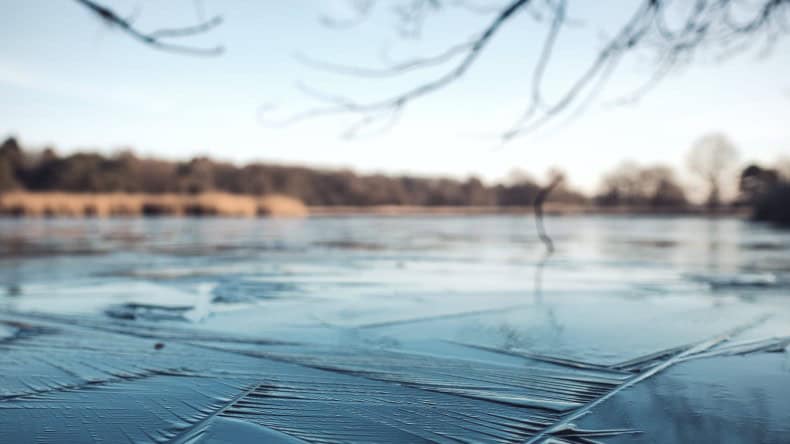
[0,216,790,443]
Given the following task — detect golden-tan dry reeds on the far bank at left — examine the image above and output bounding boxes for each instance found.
[0,191,307,217]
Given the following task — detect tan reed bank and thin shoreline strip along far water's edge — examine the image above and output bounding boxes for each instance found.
[0,191,749,218]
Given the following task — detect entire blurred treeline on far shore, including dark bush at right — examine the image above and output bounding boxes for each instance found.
[0,138,790,225]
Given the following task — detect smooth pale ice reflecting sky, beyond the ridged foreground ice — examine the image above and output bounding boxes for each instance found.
[0,216,790,362]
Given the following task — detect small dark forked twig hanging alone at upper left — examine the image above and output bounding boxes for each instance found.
[75,0,223,56]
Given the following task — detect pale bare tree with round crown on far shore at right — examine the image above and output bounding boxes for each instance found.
[688,133,738,209]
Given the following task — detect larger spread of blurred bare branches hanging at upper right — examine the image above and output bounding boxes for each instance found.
[284,0,790,141]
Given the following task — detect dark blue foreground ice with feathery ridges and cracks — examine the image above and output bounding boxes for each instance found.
[0,315,788,444]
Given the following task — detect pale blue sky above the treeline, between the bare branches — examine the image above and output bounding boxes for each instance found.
[0,0,790,191]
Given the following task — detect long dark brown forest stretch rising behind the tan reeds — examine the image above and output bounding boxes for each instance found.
[0,138,587,206]
